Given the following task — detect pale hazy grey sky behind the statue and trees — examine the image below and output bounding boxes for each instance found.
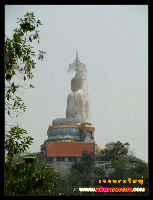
[5,5,148,162]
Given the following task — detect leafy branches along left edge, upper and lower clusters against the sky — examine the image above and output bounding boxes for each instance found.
[5,13,46,161]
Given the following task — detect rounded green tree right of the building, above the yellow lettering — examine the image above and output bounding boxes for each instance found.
[96,141,148,182]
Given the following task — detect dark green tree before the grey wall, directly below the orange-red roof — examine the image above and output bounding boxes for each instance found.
[61,151,106,195]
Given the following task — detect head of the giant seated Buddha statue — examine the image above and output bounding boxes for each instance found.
[71,76,83,92]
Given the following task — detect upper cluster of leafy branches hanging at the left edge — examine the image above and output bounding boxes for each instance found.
[5,13,46,117]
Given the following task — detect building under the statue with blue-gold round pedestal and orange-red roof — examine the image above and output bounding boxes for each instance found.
[41,124,95,176]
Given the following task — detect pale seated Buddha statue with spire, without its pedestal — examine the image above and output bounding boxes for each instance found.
[52,52,89,126]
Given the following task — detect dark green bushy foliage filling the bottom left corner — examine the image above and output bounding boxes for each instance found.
[5,157,58,195]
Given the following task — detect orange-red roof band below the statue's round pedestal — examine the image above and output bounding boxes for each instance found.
[46,142,94,156]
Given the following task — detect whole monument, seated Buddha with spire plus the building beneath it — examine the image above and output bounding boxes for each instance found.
[41,52,104,175]
